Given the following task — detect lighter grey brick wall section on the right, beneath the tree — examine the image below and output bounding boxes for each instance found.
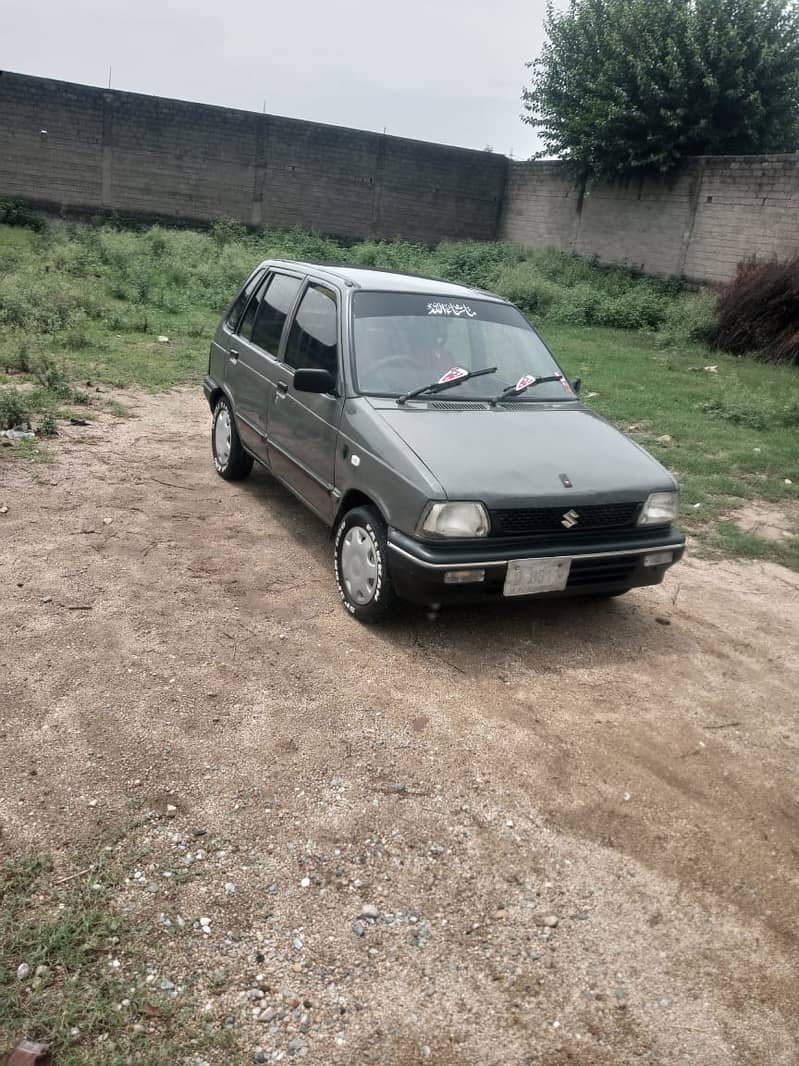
[500,155,799,282]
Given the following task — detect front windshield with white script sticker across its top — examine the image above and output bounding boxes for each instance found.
[353,292,574,403]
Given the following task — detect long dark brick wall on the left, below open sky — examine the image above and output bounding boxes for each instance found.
[0,71,508,241]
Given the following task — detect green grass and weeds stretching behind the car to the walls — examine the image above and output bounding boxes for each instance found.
[0,208,799,565]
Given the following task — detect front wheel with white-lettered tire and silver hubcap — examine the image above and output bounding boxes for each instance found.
[333,507,396,623]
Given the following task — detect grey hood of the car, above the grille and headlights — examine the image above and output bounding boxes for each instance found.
[374,403,674,507]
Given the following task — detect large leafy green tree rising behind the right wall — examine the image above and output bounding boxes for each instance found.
[522,0,799,177]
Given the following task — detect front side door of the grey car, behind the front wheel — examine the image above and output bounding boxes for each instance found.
[267,280,344,522]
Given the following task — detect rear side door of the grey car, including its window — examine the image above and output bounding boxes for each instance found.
[226,271,303,463]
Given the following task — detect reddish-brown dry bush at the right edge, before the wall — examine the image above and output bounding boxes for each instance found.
[711,256,799,366]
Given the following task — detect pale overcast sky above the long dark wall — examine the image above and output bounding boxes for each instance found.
[0,0,545,159]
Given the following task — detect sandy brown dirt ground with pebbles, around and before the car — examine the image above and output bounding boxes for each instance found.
[0,390,799,1066]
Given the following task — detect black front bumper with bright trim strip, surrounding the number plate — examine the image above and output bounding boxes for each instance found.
[388,529,685,604]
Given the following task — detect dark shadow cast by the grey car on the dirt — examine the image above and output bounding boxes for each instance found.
[242,466,696,678]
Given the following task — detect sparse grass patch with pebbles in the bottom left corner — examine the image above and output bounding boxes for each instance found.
[0,853,230,1066]
